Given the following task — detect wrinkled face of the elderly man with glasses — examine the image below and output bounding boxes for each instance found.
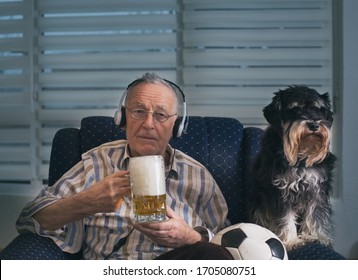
[126,83,177,158]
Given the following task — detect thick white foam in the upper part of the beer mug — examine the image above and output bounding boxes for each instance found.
[129,156,166,196]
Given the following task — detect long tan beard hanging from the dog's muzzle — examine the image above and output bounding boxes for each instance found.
[283,121,331,167]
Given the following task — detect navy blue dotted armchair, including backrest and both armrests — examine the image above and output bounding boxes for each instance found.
[1,117,343,259]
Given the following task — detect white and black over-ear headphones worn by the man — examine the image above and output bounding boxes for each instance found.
[114,79,189,138]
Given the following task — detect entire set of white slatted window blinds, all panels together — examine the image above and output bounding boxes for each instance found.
[0,0,333,190]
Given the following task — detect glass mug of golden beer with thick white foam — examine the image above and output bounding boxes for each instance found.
[129,155,166,223]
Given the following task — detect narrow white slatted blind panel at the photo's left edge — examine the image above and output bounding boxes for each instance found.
[0,1,34,187]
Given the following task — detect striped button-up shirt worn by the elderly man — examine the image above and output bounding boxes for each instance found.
[16,140,228,259]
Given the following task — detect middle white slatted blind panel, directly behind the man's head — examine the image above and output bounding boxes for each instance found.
[37,0,177,182]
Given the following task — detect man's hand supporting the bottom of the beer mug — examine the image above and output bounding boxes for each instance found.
[133,206,201,248]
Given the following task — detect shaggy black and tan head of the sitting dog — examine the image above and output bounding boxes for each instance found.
[263,86,333,167]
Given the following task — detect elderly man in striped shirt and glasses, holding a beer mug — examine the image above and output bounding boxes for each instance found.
[17,73,232,259]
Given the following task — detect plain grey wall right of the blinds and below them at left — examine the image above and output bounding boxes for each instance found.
[0,0,358,259]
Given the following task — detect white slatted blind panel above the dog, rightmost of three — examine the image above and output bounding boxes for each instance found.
[183,0,332,125]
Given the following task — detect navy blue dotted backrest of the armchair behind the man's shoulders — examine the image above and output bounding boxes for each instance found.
[48,116,263,223]
